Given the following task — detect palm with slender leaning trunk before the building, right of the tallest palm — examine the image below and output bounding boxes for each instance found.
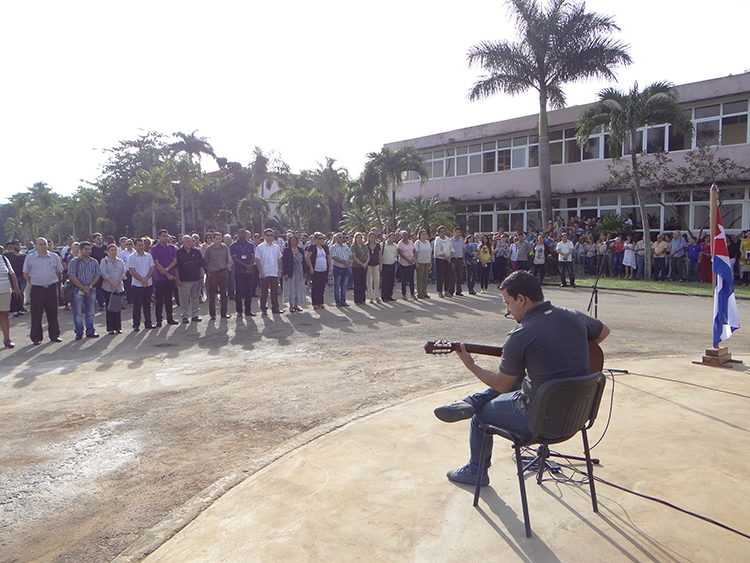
[576,82,693,279]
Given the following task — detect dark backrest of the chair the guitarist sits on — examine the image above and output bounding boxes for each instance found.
[529,372,606,443]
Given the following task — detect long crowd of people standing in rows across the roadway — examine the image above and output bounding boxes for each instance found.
[0,217,750,348]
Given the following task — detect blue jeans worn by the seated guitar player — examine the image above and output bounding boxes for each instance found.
[469,391,530,473]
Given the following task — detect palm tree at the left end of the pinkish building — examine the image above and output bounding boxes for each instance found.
[363,145,430,231]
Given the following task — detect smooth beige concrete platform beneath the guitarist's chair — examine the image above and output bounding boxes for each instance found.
[118,357,750,563]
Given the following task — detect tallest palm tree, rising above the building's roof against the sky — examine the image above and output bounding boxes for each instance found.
[468,0,632,225]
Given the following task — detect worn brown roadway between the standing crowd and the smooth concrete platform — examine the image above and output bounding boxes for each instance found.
[0,289,750,563]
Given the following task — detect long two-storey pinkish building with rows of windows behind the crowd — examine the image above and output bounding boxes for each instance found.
[386,73,750,233]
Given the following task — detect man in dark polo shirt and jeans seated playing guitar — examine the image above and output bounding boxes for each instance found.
[435,270,609,486]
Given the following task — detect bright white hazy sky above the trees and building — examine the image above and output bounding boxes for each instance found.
[0,0,750,202]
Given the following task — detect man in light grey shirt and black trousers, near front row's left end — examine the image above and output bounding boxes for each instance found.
[23,237,62,346]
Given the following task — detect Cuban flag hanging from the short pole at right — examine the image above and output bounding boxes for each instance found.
[712,204,740,348]
